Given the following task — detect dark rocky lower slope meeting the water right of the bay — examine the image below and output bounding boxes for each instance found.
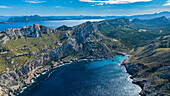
[124,63,169,96]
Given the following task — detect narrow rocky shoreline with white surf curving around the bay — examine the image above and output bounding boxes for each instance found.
[16,52,139,96]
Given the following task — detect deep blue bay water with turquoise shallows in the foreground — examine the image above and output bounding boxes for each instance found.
[20,56,141,96]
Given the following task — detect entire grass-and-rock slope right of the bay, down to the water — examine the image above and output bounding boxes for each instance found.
[125,35,170,96]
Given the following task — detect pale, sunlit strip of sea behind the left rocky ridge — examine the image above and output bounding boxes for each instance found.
[0,19,103,31]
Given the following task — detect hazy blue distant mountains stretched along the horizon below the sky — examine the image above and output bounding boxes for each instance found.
[0,11,170,24]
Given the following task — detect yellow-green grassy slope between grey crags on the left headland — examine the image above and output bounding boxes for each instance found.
[0,31,67,72]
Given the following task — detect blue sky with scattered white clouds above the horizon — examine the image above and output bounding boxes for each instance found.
[0,0,170,16]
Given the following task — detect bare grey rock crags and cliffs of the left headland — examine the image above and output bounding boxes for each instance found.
[0,22,121,96]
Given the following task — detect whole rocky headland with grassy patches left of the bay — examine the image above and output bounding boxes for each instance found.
[0,22,123,96]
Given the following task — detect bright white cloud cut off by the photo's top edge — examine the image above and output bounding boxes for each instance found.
[79,0,152,5]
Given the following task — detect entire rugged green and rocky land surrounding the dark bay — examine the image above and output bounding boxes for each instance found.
[0,17,170,96]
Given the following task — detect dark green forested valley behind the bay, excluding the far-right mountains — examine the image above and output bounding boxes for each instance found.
[95,18,162,49]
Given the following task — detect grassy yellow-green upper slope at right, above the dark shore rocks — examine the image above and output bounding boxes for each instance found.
[131,35,170,94]
